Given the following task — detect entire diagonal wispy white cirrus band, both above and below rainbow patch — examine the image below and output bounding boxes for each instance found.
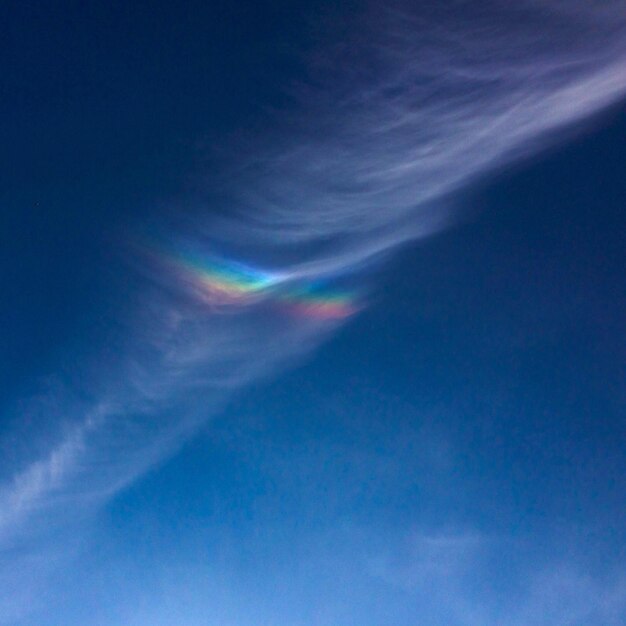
[0,0,626,620]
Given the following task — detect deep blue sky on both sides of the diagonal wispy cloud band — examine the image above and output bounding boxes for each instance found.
[0,2,626,626]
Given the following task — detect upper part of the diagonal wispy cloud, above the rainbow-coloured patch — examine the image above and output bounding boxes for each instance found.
[207,2,626,273]
